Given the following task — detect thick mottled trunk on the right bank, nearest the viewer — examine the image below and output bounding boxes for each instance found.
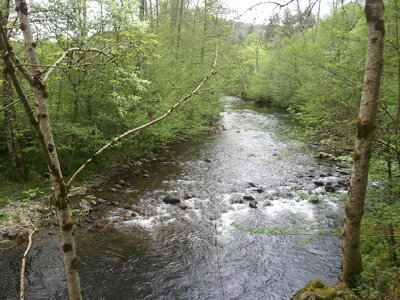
[342,0,385,287]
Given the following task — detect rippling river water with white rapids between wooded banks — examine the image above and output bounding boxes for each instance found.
[0,97,346,300]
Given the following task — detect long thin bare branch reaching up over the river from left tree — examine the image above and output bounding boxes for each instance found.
[67,43,218,190]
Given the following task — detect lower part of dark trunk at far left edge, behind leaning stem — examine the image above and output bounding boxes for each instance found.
[3,74,27,181]
